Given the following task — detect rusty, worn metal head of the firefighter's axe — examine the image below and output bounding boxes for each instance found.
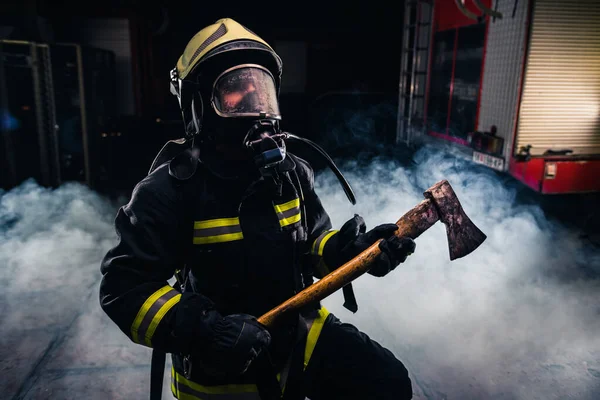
[423,180,487,260]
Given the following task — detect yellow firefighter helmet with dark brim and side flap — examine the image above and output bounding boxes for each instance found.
[171,18,282,135]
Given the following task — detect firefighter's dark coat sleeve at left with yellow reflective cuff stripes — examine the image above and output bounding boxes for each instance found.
[100,165,218,353]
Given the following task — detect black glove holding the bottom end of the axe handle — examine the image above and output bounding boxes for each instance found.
[195,310,271,378]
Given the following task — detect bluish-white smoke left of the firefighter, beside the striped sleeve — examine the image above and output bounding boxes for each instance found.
[0,180,159,399]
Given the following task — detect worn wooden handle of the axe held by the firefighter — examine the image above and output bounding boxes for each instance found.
[258,199,439,327]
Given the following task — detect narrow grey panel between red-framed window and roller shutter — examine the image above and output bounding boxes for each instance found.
[477,1,529,166]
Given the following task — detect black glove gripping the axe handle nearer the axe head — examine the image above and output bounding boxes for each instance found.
[339,215,416,277]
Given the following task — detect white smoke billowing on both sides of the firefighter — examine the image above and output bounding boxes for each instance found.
[0,144,600,400]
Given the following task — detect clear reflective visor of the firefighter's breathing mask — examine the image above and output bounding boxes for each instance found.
[213,65,281,118]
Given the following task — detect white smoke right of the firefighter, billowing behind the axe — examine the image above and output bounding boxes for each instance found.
[316,146,600,400]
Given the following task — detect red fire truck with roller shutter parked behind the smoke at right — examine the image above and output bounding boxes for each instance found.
[396,0,600,194]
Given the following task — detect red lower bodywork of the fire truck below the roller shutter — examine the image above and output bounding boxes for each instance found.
[510,158,600,194]
